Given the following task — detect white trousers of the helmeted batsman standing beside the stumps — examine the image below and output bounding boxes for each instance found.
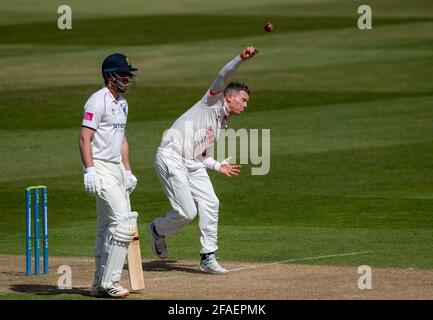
[93,159,131,279]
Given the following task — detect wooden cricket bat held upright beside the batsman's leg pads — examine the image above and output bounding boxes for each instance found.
[128,231,144,291]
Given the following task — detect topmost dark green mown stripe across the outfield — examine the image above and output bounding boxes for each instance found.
[0,12,433,47]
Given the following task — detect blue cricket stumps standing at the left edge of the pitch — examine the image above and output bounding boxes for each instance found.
[26,186,48,276]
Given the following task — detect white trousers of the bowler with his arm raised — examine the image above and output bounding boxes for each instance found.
[154,147,219,253]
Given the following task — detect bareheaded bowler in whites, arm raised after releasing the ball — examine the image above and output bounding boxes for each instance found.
[148,47,258,274]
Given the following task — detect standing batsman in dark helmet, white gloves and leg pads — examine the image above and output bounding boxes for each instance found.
[79,53,138,298]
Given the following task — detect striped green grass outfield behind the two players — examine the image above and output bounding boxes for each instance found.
[0,0,433,284]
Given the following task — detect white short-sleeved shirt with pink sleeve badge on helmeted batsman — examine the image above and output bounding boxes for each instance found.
[82,87,128,163]
